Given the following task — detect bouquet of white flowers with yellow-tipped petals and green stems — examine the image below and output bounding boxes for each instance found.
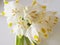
[2,0,58,45]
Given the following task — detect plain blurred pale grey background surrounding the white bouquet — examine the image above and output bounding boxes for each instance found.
[0,0,60,45]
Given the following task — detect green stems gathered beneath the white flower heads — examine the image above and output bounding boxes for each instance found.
[16,36,36,45]
